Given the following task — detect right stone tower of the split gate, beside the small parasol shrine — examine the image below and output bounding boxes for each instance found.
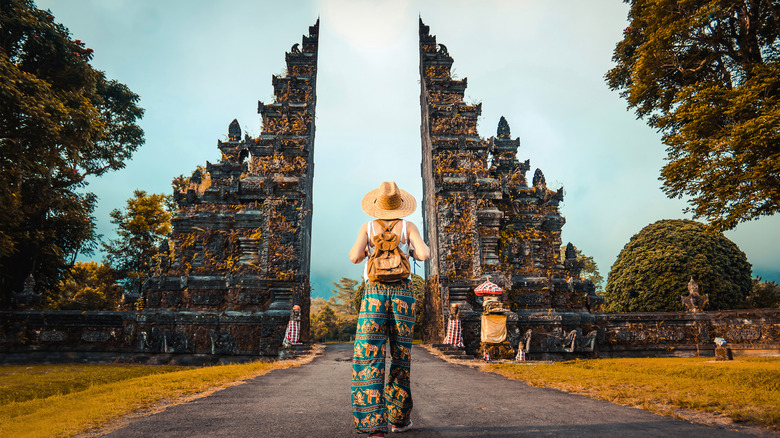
[419,20,597,352]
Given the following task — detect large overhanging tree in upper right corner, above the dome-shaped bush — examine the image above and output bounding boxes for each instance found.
[606,0,780,231]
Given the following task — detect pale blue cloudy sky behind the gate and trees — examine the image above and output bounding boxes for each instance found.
[36,0,780,297]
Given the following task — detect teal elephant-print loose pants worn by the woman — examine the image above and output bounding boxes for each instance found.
[352,280,414,433]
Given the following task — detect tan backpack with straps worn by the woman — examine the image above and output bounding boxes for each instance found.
[366,220,411,283]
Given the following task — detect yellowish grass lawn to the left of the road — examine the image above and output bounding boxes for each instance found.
[0,361,301,437]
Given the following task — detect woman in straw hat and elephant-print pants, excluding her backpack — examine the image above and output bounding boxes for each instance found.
[349,181,429,437]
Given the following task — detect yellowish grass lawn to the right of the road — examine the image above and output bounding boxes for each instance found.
[485,357,780,430]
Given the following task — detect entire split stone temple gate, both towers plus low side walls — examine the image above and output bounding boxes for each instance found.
[0,20,780,364]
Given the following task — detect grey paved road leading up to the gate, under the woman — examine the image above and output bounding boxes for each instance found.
[107,344,756,438]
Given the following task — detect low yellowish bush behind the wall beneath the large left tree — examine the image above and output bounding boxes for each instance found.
[47,261,122,310]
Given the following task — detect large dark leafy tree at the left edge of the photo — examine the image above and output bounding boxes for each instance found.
[0,0,144,307]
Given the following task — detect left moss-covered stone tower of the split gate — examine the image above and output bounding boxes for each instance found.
[139,20,319,355]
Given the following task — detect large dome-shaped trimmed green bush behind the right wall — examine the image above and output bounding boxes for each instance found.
[604,219,752,312]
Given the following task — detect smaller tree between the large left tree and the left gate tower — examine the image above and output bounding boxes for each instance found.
[103,190,171,289]
